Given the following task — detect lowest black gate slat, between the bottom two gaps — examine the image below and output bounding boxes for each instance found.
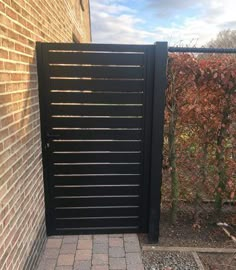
[56,217,139,228]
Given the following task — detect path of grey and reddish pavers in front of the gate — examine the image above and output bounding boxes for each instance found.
[37,234,144,270]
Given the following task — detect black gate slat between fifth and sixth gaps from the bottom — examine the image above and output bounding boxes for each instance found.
[51,175,142,185]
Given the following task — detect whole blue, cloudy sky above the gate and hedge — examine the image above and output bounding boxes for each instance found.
[90,0,236,47]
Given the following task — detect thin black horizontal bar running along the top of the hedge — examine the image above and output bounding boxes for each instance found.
[168,47,236,53]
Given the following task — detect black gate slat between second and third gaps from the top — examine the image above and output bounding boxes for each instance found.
[49,66,144,79]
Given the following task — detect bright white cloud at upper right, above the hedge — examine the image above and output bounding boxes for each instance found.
[156,0,236,46]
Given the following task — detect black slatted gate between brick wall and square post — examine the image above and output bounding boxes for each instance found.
[37,43,165,240]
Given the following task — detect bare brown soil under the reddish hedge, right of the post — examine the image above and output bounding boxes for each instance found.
[140,204,236,248]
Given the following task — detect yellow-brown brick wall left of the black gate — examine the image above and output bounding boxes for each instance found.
[0,0,90,270]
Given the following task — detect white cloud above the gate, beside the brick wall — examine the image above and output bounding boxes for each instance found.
[91,0,154,43]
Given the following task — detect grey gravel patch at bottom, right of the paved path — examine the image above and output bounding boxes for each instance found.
[143,251,198,270]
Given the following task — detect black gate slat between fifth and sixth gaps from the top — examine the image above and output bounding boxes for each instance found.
[51,105,143,116]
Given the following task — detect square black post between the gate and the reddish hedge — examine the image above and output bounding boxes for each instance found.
[148,42,168,242]
